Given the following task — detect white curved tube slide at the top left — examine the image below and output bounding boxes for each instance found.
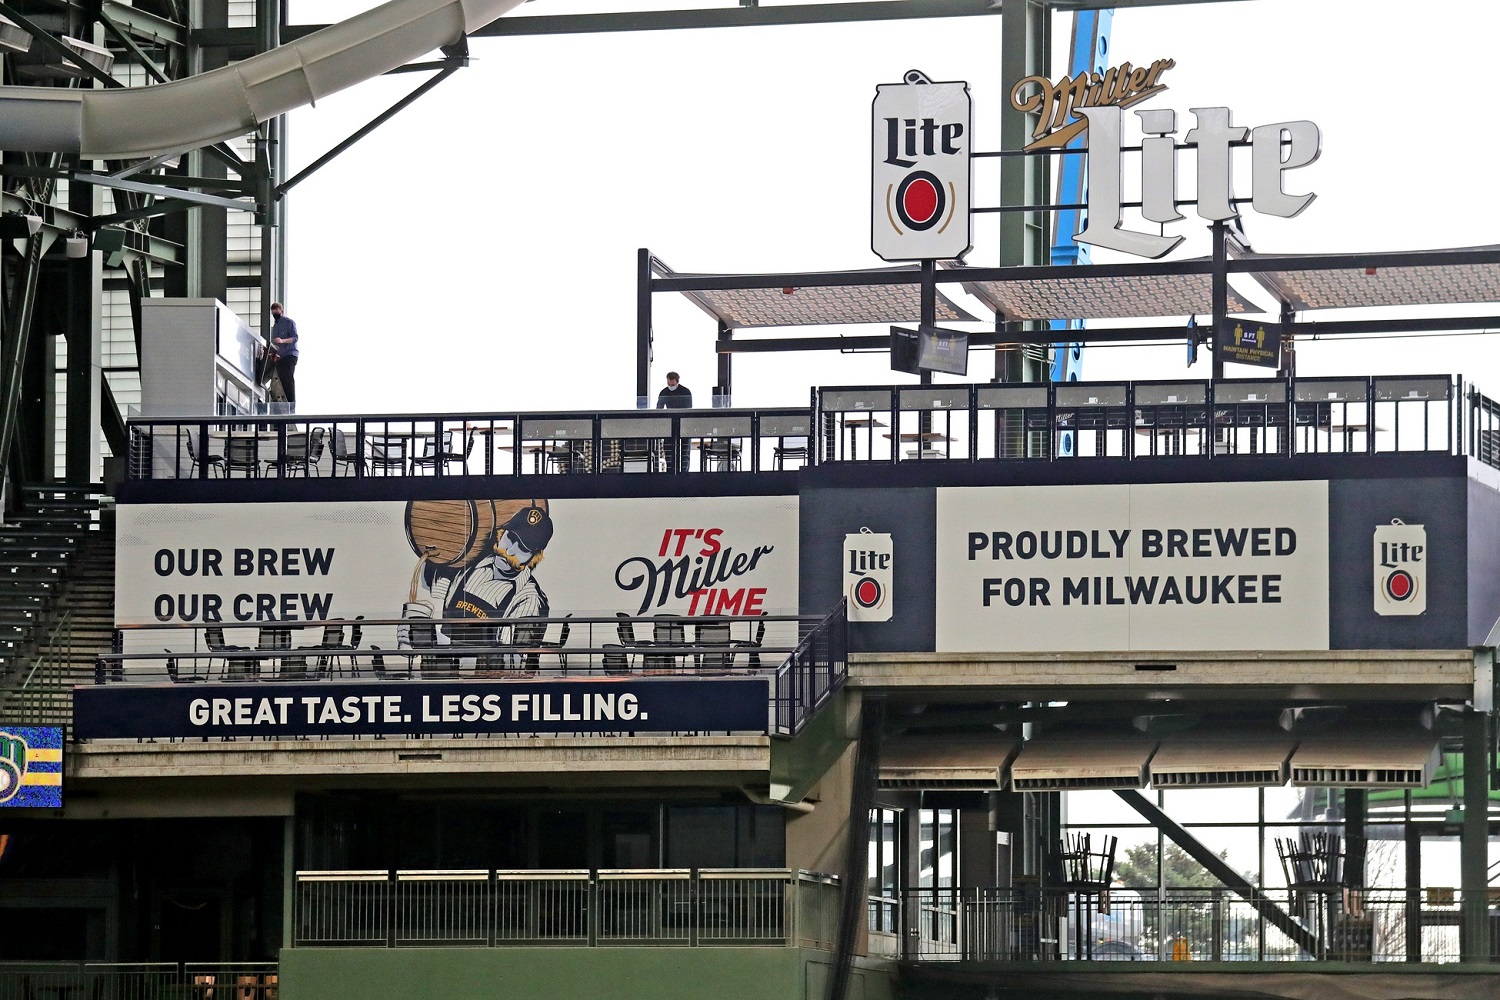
[0,0,522,159]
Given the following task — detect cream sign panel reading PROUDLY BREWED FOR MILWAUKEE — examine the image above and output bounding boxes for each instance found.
[936,481,1329,652]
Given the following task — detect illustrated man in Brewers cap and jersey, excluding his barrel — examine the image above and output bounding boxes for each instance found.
[396,507,552,648]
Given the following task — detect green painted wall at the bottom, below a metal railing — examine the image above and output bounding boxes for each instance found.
[281,948,894,1000]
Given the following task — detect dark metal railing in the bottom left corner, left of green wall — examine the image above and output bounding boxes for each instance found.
[0,961,279,1000]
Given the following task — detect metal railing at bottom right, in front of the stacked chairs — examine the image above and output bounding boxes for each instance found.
[870,888,1500,963]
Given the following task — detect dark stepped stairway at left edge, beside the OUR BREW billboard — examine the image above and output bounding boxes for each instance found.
[0,483,114,726]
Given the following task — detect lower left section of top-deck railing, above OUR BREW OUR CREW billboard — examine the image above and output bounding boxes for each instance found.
[128,408,812,480]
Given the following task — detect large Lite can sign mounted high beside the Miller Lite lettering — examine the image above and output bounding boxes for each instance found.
[870,69,974,261]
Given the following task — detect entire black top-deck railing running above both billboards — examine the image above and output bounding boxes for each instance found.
[128,375,1500,480]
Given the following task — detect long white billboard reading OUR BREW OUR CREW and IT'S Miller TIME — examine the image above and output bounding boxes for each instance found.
[116,496,798,638]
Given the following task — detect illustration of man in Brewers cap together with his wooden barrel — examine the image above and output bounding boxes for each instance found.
[398,499,552,646]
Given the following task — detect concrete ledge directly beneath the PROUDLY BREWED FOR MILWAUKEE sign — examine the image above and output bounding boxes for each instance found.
[849,649,1475,700]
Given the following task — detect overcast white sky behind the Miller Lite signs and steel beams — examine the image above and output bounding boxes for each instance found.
[287,0,1500,414]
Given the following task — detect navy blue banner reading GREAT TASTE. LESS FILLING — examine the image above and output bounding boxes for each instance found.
[74,678,770,739]
